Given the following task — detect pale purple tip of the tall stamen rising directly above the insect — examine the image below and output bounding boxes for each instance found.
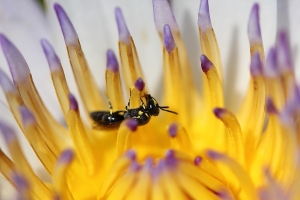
[115,7,130,44]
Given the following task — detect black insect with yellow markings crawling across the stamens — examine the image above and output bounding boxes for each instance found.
[90,91,177,129]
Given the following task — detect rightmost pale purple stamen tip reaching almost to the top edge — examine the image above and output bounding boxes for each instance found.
[248,4,262,44]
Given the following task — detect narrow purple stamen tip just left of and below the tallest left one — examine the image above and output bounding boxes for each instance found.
[41,39,62,72]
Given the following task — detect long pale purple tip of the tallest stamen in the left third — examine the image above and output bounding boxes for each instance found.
[54,3,78,46]
